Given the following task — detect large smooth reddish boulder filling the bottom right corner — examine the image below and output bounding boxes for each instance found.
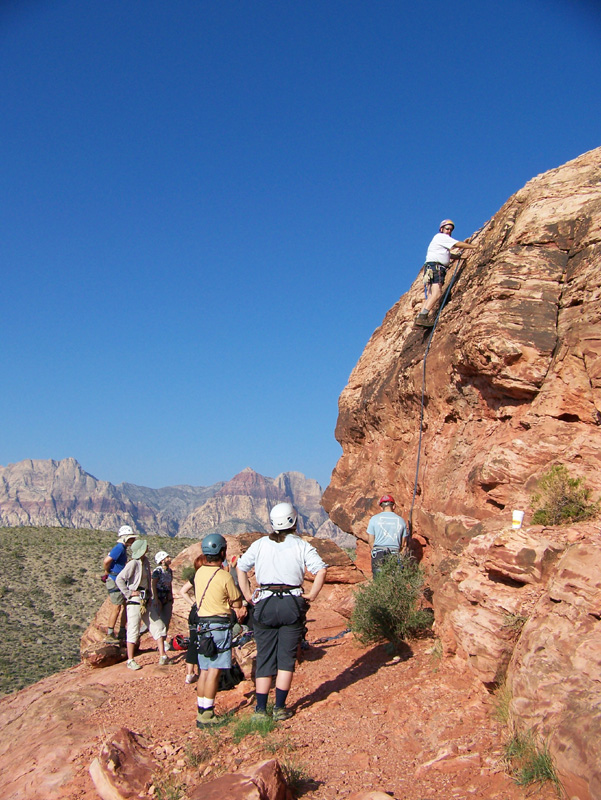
[508,535,601,800]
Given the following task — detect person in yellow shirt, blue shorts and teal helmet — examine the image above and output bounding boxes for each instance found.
[194,533,246,728]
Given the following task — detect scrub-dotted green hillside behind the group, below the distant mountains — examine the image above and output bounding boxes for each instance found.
[0,528,190,695]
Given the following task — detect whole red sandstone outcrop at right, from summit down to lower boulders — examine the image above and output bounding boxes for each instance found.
[323,149,601,800]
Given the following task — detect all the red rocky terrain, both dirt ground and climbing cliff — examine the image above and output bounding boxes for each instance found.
[0,149,601,800]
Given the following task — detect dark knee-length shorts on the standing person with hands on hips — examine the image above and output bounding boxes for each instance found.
[254,594,308,678]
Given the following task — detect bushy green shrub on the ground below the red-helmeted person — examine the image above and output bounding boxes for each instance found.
[351,555,433,645]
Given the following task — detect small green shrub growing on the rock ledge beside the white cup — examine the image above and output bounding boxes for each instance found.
[531,464,599,525]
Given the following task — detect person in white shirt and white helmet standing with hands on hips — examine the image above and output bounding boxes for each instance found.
[237,503,327,721]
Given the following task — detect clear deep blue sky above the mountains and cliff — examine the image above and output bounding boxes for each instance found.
[0,0,601,487]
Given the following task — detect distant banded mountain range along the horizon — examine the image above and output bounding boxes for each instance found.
[0,458,355,545]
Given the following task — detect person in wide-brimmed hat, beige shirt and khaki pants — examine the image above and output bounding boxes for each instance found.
[116,539,152,670]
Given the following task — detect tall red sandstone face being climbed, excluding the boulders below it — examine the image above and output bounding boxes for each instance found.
[324,149,601,540]
